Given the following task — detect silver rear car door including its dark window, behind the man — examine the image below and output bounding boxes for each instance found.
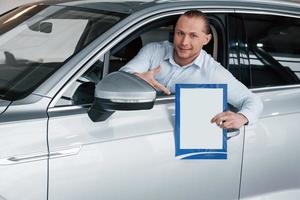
[238,10,300,200]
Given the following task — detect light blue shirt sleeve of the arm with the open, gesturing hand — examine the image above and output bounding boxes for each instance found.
[120,43,156,73]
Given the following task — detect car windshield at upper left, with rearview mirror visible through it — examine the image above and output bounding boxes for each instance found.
[0,5,124,100]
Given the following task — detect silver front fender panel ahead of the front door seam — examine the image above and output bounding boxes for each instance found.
[0,108,48,200]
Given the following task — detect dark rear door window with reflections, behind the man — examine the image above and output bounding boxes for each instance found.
[243,14,300,88]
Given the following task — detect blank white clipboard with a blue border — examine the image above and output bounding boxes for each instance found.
[175,84,227,159]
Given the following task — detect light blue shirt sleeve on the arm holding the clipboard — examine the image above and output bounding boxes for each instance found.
[213,64,263,125]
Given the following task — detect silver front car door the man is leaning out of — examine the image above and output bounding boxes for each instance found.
[48,8,244,200]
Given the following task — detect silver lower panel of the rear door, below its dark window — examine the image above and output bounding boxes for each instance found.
[241,88,300,200]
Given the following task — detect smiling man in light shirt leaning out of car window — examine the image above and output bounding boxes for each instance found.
[121,10,263,129]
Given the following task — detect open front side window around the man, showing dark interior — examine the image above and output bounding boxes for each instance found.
[56,15,223,106]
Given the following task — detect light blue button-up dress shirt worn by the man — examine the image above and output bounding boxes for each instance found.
[120,41,263,124]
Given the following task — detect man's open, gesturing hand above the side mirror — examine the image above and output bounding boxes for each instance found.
[134,66,171,95]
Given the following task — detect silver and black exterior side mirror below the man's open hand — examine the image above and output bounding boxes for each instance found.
[88,71,156,122]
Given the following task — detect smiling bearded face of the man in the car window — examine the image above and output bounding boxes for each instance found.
[173,16,211,66]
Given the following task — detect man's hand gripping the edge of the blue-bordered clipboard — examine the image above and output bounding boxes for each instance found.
[211,111,248,129]
